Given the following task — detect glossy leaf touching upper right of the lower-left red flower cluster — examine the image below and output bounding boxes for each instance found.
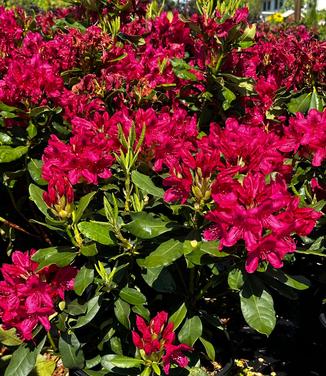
[32,247,77,270]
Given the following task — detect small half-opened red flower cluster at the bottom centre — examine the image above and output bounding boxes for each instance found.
[132,311,192,375]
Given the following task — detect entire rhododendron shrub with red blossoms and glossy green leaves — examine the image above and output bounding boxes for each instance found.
[0,1,326,376]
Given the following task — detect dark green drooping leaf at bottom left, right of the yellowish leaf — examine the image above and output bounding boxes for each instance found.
[59,333,85,369]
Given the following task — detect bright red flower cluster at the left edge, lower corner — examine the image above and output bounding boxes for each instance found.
[0,249,77,341]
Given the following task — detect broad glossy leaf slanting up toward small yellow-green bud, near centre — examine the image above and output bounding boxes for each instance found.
[143,239,183,268]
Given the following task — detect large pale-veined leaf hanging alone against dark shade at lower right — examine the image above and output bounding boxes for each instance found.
[240,277,276,336]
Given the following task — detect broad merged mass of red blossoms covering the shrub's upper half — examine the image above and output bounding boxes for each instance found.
[0,5,326,272]
